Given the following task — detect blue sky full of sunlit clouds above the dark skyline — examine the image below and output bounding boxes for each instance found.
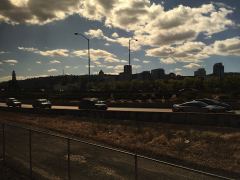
[0,0,240,81]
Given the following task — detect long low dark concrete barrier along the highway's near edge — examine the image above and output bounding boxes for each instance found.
[0,107,240,128]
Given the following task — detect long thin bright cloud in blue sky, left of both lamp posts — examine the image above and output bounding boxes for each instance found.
[18,47,69,57]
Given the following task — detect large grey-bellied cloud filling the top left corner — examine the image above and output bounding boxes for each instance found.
[0,0,79,25]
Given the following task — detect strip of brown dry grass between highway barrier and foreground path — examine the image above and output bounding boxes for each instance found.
[0,112,240,173]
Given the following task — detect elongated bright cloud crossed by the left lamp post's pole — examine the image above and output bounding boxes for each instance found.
[72,49,120,63]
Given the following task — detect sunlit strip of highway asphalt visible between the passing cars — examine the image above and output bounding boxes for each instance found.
[0,103,172,112]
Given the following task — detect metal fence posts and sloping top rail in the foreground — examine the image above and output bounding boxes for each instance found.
[0,123,235,180]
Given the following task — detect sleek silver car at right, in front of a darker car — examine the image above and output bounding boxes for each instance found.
[172,100,227,113]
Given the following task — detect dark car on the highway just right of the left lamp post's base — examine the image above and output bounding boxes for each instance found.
[78,98,107,110]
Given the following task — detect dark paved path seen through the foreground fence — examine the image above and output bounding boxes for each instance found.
[0,126,225,180]
